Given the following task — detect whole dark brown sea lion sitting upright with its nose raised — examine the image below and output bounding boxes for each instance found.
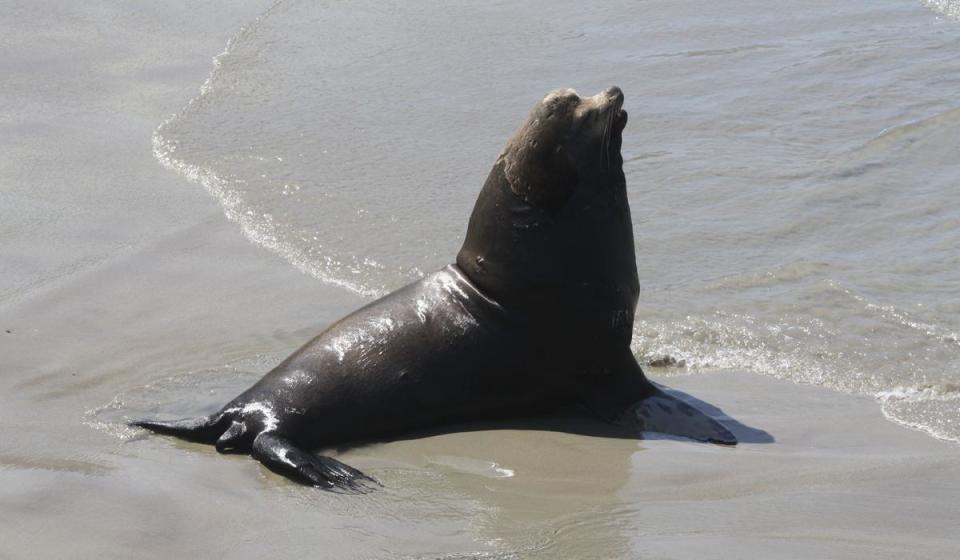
[132,87,736,491]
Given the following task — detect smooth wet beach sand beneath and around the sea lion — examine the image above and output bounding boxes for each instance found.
[0,2,960,559]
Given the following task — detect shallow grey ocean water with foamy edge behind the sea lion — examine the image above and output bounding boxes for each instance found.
[153,0,960,442]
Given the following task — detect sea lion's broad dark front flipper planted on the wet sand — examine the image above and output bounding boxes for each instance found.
[581,350,737,445]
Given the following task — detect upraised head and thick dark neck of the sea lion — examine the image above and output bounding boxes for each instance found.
[457,87,639,324]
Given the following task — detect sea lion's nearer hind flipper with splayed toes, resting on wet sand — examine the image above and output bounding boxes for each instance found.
[252,432,380,493]
